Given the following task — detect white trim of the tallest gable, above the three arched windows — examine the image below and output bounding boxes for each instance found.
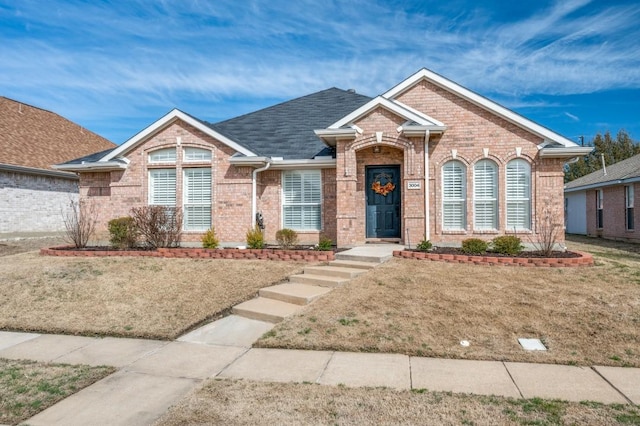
[382,68,578,147]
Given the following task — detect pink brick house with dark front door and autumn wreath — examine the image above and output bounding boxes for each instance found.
[57,69,590,247]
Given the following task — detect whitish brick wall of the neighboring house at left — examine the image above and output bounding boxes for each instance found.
[0,171,78,234]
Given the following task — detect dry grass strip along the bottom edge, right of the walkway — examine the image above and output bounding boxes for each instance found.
[156,380,640,426]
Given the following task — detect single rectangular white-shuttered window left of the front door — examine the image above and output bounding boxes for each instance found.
[282,170,322,231]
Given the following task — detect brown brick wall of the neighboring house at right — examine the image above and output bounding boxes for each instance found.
[587,183,640,242]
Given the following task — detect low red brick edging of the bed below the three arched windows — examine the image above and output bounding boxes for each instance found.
[393,250,593,268]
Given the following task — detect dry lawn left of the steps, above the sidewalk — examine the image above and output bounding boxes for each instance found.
[0,252,303,339]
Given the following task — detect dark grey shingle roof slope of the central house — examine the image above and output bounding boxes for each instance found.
[209,87,371,159]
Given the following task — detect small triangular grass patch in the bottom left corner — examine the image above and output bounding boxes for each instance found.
[0,358,115,424]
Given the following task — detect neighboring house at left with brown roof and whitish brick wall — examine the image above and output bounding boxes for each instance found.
[0,96,115,237]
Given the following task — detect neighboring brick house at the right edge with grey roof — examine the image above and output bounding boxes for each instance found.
[564,154,640,241]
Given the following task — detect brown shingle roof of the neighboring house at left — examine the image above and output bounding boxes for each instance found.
[0,96,115,170]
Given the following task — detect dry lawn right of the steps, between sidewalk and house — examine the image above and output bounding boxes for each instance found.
[257,236,640,367]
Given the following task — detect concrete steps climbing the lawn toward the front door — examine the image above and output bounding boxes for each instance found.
[231,253,378,323]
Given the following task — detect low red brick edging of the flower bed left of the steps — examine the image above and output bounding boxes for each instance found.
[40,246,335,262]
